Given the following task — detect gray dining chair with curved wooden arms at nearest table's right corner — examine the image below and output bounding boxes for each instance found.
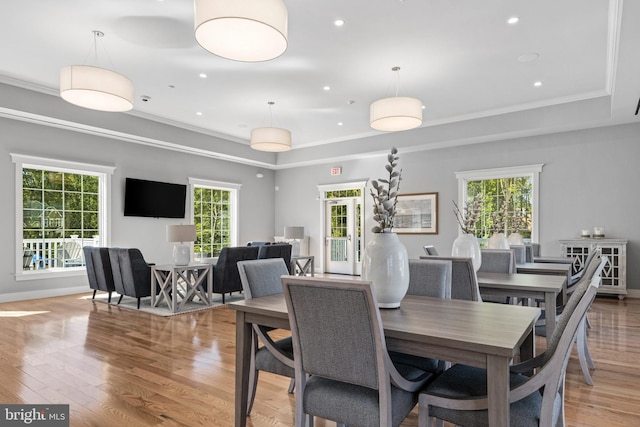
[418,258,606,427]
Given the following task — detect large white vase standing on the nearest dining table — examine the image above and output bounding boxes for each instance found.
[362,233,409,308]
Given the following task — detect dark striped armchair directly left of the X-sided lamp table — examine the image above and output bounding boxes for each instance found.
[109,248,153,308]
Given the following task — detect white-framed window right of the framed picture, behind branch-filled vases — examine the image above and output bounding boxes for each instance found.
[456,164,544,242]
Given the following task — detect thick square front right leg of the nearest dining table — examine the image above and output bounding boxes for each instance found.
[487,356,509,427]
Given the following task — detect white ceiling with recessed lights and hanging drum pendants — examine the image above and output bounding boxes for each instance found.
[0,0,640,160]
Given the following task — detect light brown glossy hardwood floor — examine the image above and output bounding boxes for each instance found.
[0,295,640,427]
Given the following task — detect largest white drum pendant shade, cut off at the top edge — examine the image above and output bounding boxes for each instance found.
[195,0,288,62]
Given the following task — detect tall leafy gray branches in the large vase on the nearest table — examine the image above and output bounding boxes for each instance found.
[371,147,402,233]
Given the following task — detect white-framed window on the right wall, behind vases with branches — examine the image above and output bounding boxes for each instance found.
[456,164,543,242]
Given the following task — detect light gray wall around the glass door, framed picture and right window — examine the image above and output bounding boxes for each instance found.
[275,120,640,296]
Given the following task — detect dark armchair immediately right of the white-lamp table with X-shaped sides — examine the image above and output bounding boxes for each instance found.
[213,246,259,304]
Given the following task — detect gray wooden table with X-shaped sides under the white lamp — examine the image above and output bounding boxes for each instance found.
[151,264,213,313]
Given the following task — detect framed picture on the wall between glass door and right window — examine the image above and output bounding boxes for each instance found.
[393,192,438,234]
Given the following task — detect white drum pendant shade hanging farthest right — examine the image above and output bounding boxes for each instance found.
[369,96,422,131]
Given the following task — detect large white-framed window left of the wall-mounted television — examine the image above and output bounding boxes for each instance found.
[11,153,115,280]
